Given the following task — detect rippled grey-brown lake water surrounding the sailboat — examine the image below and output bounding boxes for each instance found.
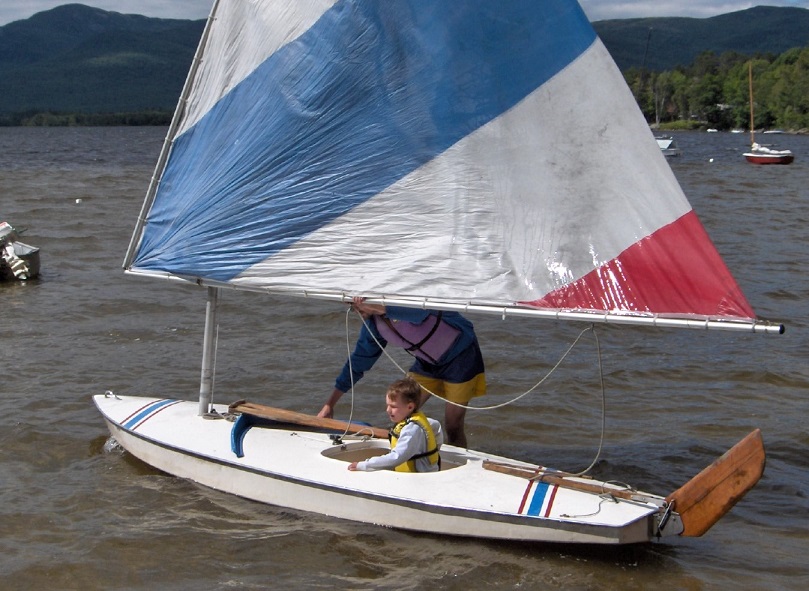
[0,128,809,591]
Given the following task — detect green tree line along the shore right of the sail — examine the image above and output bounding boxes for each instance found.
[624,47,809,132]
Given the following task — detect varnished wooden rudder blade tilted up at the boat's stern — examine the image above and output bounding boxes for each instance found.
[666,429,766,536]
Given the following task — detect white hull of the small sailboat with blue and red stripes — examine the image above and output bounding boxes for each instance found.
[94,396,681,544]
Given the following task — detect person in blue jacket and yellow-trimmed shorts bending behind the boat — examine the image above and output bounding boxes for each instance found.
[318,298,486,447]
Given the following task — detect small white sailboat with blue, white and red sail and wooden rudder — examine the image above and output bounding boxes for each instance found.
[93,0,783,544]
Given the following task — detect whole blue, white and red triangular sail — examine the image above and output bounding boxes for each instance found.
[126,0,754,320]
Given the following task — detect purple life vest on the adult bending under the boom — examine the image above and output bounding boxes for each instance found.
[374,312,461,365]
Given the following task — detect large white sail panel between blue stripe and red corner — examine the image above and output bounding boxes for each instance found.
[234,41,691,302]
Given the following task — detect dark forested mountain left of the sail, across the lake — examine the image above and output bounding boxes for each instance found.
[0,4,204,124]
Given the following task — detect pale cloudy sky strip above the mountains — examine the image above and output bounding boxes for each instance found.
[0,0,809,26]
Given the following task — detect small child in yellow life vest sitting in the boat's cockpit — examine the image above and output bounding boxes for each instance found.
[348,378,444,472]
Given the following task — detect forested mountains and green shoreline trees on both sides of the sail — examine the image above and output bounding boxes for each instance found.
[0,4,809,130]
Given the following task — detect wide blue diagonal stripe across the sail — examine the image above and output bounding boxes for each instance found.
[133,0,595,281]
